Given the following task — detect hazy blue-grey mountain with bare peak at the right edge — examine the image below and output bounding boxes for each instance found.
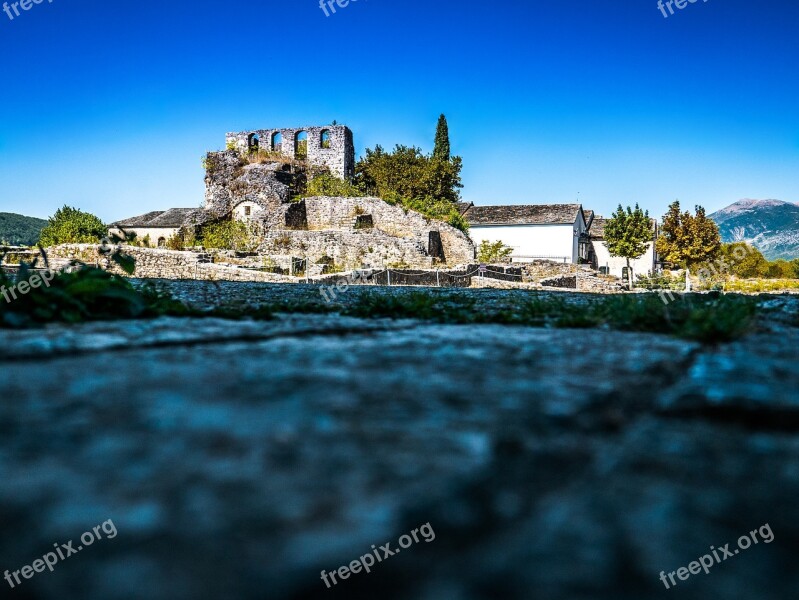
[710,199,799,260]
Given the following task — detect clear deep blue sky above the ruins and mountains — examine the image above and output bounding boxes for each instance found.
[0,0,799,221]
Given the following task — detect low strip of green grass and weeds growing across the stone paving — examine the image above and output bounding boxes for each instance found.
[0,258,776,344]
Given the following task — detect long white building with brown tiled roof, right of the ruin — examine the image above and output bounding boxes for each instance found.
[460,203,589,264]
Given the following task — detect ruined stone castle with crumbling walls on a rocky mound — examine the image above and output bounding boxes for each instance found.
[115,125,474,274]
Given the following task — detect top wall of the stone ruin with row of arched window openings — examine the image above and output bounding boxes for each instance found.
[227,125,355,179]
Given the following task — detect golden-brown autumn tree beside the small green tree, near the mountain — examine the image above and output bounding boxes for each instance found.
[655,200,721,268]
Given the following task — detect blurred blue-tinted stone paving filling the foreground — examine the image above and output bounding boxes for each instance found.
[0,292,799,600]
